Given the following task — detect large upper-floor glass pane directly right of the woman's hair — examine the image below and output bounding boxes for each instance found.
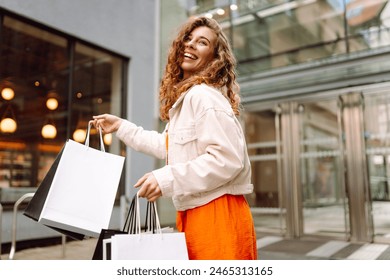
[222,0,346,75]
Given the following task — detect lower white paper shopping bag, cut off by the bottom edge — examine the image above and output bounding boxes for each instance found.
[109,194,188,260]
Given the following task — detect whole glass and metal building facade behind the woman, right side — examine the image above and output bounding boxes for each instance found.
[161,0,390,242]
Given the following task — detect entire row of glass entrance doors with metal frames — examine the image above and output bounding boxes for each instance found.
[245,86,390,243]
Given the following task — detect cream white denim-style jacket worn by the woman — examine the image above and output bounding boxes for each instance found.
[116,84,253,211]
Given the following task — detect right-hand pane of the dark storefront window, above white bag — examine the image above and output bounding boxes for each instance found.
[70,43,123,153]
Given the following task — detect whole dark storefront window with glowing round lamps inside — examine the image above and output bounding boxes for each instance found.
[0,16,127,205]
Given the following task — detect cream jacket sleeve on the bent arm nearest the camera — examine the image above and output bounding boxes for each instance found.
[153,89,245,196]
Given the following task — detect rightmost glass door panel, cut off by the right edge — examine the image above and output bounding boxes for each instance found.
[364,91,390,243]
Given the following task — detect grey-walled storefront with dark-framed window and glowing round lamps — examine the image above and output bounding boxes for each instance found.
[0,0,159,244]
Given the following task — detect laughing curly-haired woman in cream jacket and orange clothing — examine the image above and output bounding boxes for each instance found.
[93,17,257,260]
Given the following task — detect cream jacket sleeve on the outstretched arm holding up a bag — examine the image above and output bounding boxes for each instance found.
[116,120,166,159]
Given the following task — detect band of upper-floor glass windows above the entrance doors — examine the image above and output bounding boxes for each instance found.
[162,0,390,75]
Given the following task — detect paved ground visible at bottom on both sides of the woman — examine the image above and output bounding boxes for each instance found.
[1,235,390,260]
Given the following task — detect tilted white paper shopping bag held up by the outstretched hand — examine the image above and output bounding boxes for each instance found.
[38,123,124,237]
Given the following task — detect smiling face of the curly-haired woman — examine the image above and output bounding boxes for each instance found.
[181,26,217,79]
